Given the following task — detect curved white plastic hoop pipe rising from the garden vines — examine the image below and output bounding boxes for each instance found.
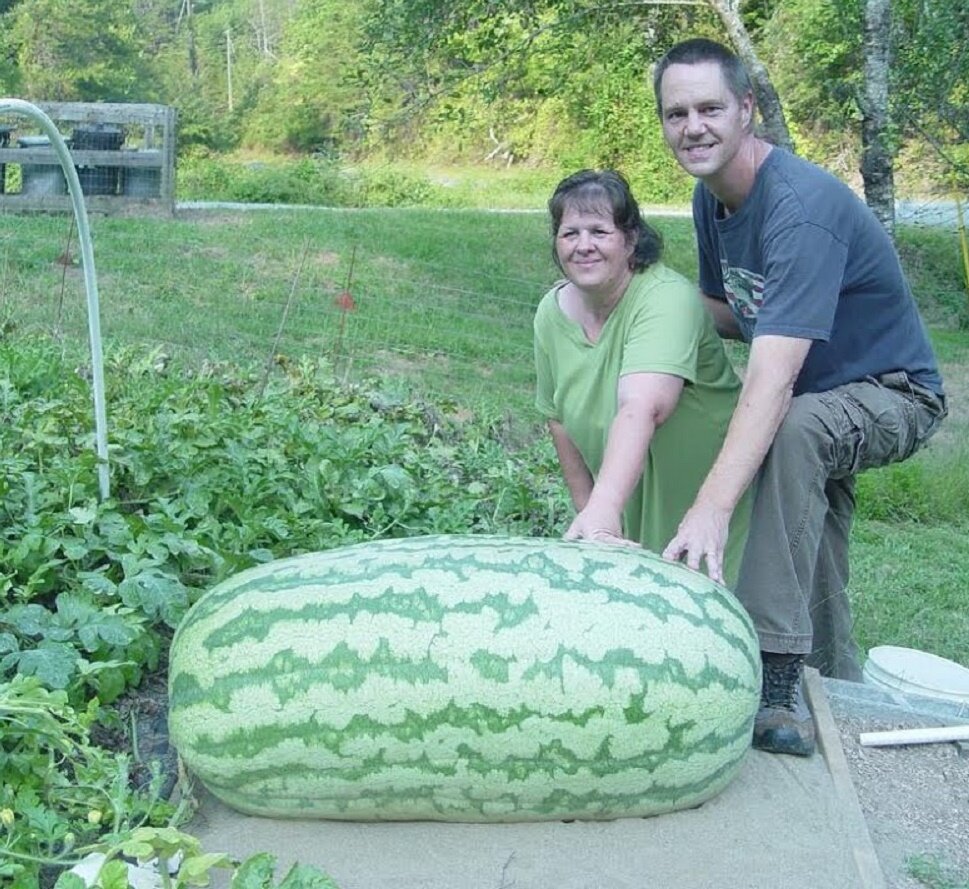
[0,99,110,501]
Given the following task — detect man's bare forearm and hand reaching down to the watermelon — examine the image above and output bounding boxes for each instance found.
[663,336,812,583]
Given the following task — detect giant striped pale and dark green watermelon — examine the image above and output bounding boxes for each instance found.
[169,536,760,821]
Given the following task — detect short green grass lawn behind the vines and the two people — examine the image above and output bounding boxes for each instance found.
[0,197,969,660]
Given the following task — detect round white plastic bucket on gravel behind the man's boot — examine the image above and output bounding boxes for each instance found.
[862,645,969,705]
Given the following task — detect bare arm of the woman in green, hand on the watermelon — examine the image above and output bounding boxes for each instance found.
[565,373,683,540]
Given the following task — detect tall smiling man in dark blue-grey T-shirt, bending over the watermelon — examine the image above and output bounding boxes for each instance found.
[653,39,946,755]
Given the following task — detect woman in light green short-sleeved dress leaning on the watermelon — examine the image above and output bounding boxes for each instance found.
[535,170,749,583]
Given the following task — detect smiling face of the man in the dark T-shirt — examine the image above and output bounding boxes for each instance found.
[660,62,753,181]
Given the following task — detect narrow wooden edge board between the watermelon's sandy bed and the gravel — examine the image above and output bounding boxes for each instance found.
[804,667,888,889]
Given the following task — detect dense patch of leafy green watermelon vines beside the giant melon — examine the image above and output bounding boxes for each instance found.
[0,337,565,887]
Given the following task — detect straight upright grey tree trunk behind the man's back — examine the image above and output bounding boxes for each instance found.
[861,0,895,237]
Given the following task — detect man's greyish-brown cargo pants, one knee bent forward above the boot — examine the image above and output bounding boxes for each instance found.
[736,373,946,680]
